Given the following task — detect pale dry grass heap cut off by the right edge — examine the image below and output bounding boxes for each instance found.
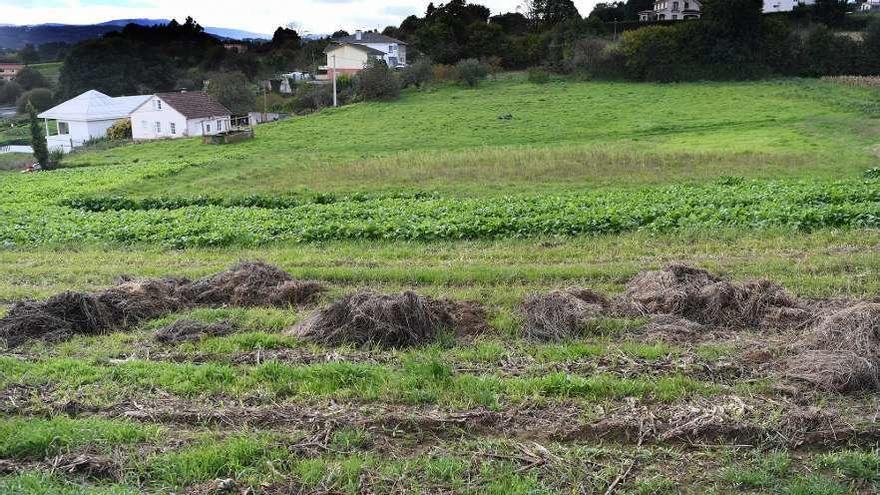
[786,303,880,392]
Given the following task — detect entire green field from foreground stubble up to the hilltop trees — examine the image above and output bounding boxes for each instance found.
[0,75,880,495]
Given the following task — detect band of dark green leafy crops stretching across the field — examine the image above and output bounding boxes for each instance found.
[0,164,880,248]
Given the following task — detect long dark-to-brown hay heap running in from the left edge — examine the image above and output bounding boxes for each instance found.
[0,262,326,348]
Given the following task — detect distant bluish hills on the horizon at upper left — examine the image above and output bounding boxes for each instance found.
[0,19,272,48]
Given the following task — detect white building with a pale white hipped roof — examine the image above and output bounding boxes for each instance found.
[38,90,150,153]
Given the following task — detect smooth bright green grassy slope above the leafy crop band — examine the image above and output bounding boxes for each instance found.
[62,78,880,196]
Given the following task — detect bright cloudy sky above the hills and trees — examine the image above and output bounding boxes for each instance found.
[0,0,597,33]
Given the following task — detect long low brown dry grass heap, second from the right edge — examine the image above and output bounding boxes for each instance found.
[622,264,810,327]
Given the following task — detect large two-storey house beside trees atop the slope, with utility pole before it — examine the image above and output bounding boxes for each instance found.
[317,30,406,80]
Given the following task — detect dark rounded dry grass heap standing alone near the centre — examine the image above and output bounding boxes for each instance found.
[290,291,454,348]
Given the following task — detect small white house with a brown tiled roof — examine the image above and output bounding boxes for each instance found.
[131,91,232,140]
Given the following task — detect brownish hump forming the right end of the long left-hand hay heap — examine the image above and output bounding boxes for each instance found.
[180,261,326,307]
